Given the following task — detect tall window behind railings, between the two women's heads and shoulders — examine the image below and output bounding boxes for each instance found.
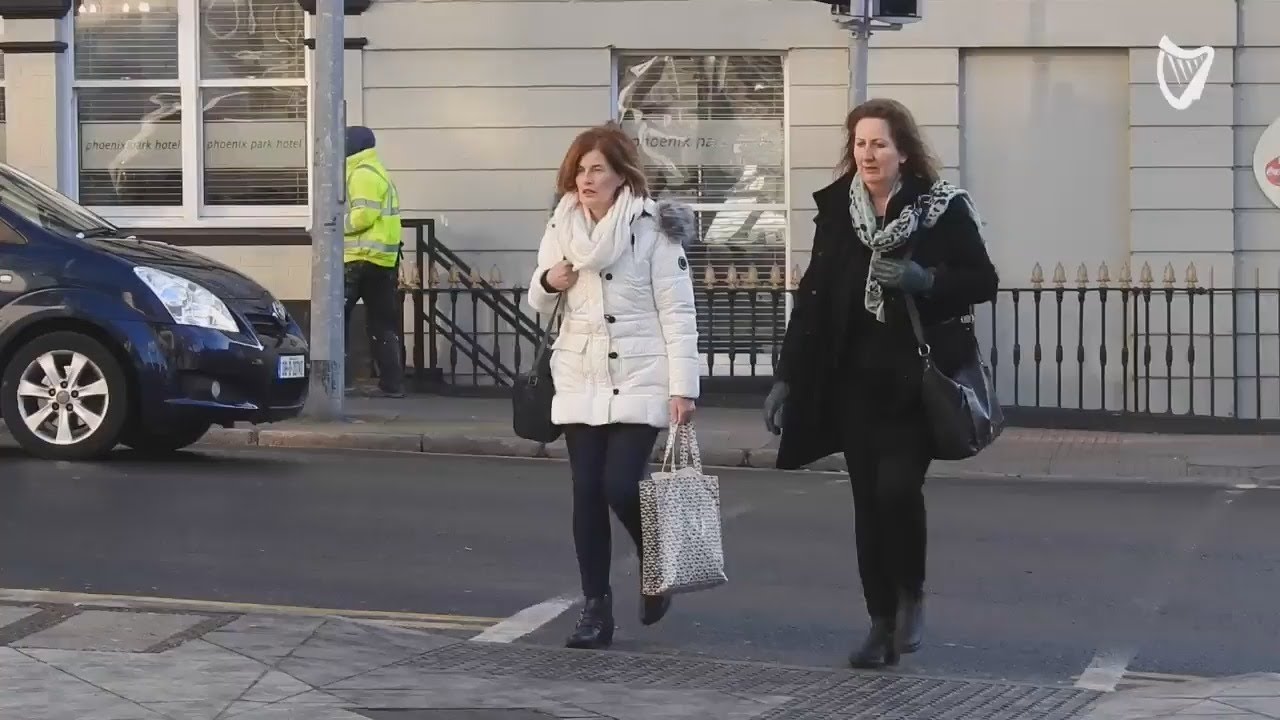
[617,54,787,374]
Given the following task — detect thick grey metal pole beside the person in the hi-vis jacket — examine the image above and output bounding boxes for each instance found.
[306,0,347,420]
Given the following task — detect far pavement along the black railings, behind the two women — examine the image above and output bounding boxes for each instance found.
[0,396,1280,488]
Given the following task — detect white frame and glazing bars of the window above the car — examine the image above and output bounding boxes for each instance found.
[60,0,315,228]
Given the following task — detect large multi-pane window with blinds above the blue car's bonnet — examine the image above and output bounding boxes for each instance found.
[73,0,310,220]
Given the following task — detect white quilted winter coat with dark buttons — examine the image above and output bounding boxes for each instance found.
[529,200,700,429]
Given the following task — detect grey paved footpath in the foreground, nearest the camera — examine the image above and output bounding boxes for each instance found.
[0,603,1280,720]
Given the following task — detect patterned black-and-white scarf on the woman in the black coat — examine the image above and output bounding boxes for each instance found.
[849,174,982,323]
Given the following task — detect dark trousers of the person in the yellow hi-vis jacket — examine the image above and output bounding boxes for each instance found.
[343,261,404,393]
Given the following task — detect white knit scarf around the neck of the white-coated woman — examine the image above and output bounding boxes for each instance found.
[552,186,645,273]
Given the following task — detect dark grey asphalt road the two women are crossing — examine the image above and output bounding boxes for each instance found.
[0,438,1280,684]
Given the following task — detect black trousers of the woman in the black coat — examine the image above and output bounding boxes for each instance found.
[842,365,933,619]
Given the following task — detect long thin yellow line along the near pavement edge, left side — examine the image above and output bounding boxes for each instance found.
[0,589,502,630]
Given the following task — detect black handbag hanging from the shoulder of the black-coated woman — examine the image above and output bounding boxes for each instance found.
[906,286,1005,460]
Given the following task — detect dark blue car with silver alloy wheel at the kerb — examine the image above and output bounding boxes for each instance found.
[0,164,310,460]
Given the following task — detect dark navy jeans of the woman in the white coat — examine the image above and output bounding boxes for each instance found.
[564,424,658,597]
